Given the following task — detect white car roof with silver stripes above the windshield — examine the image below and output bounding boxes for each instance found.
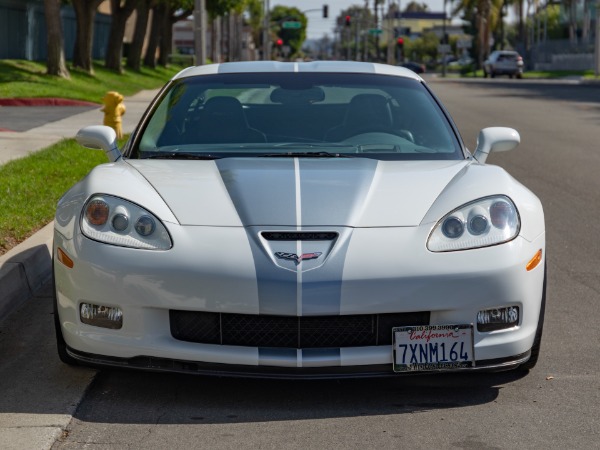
[173,61,423,81]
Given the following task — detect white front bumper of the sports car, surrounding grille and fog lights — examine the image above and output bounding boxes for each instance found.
[55,226,544,378]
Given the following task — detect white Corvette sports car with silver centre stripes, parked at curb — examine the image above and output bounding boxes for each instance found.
[54,62,546,378]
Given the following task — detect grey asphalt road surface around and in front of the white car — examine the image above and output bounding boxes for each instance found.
[0,79,600,449]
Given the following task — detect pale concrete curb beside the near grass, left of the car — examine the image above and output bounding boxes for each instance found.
[0,222,54,321]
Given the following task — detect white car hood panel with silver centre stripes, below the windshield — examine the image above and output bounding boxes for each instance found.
[127,158,470,227]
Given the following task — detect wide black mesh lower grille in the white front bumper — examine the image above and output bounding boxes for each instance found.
[169,310,429,348]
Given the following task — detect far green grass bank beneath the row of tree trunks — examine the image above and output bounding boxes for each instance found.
[0,59,184,103]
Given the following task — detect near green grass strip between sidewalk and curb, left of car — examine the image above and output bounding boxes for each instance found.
[0,139,108,255]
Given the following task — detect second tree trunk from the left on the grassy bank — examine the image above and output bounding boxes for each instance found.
[73,0,102,73]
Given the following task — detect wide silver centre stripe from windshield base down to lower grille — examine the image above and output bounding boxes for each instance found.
[216,158,377,316]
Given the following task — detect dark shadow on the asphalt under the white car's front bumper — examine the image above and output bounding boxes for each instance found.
[74,370,523,424]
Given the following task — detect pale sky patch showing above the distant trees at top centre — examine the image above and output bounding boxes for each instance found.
[269,0,450,39]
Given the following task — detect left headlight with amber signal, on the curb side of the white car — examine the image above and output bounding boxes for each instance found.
[81,194,173,250]
